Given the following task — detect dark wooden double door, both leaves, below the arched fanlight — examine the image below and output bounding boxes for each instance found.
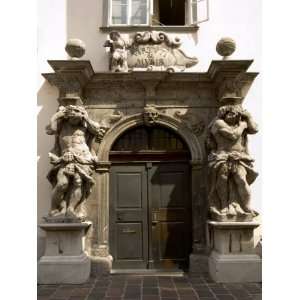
[110,163,192,269]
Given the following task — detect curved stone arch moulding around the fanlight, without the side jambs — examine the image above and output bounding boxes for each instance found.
[98,113,203,163]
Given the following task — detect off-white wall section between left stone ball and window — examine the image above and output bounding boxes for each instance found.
[67,0,108,72]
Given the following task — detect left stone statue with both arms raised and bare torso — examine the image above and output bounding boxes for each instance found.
[46,105,105,219]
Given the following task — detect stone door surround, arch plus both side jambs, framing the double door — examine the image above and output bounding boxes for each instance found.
[92,112,207,257]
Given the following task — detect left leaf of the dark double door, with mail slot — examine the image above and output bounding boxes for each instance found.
[110,166,148,268]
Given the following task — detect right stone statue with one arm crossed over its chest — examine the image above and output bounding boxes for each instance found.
[207,104,258,221]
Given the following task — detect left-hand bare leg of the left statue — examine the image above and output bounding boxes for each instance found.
[50,168,69,215]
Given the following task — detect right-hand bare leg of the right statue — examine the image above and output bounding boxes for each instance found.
[234,165,252,212]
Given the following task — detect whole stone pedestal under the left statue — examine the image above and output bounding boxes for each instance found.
[38,222,91,284]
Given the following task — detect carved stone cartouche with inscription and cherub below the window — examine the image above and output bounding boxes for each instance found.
[104,31,198,72]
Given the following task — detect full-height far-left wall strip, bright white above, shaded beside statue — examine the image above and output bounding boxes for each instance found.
[37,0,67,257]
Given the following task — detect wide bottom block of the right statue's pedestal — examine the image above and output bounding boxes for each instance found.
[208,251,262,282]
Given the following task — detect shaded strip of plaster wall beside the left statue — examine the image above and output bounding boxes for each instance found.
[37,81,58,258]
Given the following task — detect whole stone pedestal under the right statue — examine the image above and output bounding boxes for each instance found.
[208,221,261,282]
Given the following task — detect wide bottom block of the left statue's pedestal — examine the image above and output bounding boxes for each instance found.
[38,253,91,284]
